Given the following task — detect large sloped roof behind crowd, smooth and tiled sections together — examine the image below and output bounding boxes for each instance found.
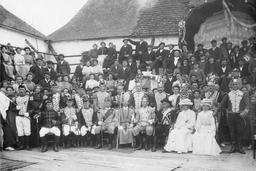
[48,0,189,41]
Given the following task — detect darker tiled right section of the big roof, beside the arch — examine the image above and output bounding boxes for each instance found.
[132,0,189,36]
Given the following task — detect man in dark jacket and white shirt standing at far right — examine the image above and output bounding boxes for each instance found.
[221,79,249,154]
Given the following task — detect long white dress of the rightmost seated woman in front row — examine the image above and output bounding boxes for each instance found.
[193,110,221,156]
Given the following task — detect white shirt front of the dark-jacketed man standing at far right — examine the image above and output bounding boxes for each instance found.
[228,90,244,112]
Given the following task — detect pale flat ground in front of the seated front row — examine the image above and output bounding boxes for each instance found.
[0,148,256,171]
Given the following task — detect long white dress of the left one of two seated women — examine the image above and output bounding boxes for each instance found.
[164,109,196,153]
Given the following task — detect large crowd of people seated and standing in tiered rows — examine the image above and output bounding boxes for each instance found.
[0,37,256,155]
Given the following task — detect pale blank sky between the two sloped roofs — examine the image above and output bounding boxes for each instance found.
[0,0,87,36]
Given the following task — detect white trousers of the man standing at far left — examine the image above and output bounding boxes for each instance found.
[16,116,31,137]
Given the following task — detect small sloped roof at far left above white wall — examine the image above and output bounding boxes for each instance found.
[0,5,46,39]
